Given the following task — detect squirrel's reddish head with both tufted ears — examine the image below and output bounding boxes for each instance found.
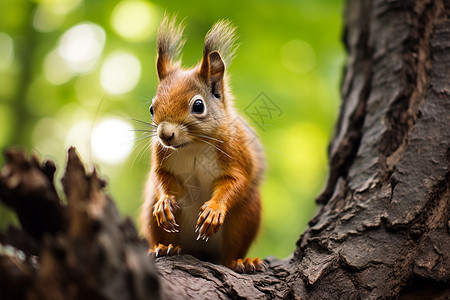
[150,18,235,148]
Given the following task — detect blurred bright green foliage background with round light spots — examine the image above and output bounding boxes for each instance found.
[0,0,344,258]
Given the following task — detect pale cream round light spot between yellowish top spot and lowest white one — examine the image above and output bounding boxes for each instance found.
[100,52,141,94]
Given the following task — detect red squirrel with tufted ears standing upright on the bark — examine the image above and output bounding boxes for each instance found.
[141,17,265,273]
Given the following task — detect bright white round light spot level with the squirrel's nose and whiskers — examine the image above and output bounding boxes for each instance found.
[91,118,135,165]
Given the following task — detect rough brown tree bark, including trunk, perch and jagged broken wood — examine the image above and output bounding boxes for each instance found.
[0,0,450,299]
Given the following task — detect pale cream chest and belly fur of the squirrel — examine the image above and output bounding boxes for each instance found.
[167,144,222,254]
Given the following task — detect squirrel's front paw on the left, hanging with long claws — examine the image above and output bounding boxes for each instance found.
[153,195,179,232]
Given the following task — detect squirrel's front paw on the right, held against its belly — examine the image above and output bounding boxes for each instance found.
[195,201,225,242]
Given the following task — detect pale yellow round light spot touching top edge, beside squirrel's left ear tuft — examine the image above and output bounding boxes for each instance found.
[111,0,158,41]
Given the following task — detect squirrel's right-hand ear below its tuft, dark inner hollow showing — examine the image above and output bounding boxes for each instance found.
[200,51,225,98]
